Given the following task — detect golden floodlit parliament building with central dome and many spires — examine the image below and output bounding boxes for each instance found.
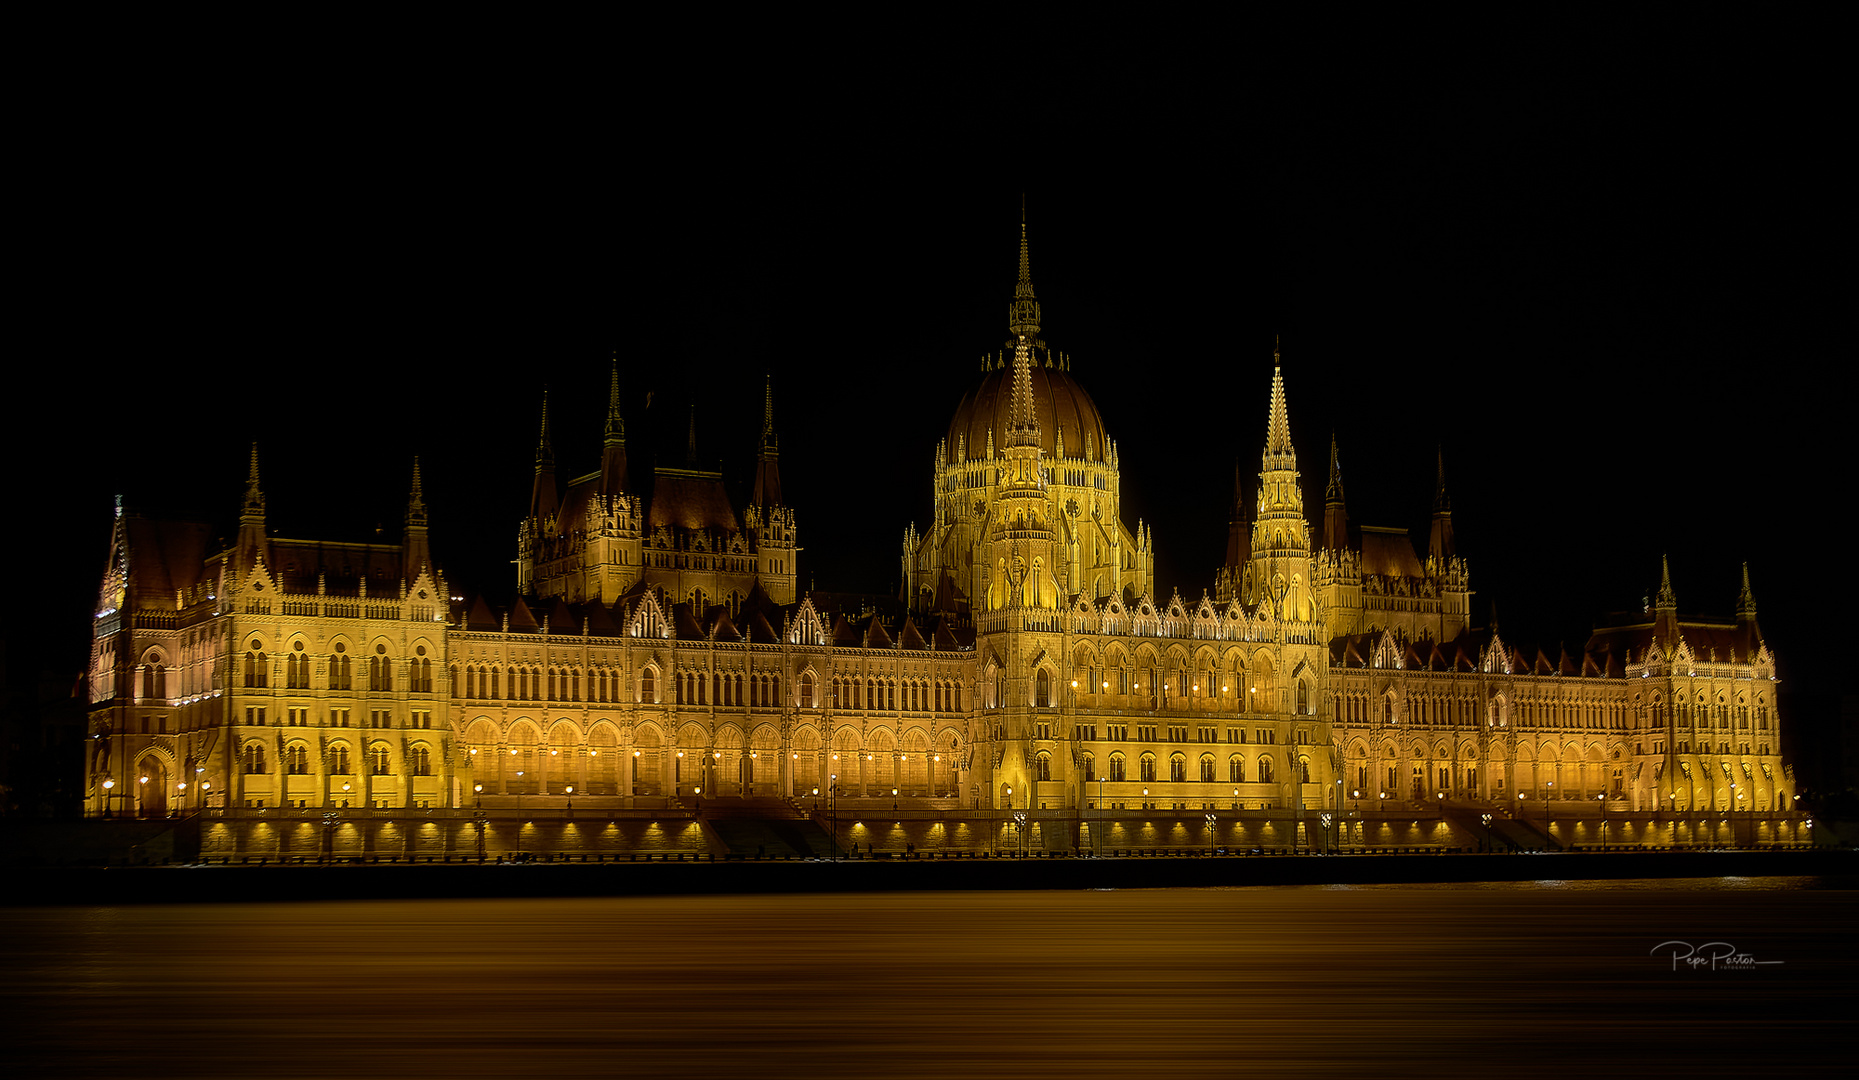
[86,225,1794,844]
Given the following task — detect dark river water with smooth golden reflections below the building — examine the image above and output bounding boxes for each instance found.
[0,877,1859,1080]
